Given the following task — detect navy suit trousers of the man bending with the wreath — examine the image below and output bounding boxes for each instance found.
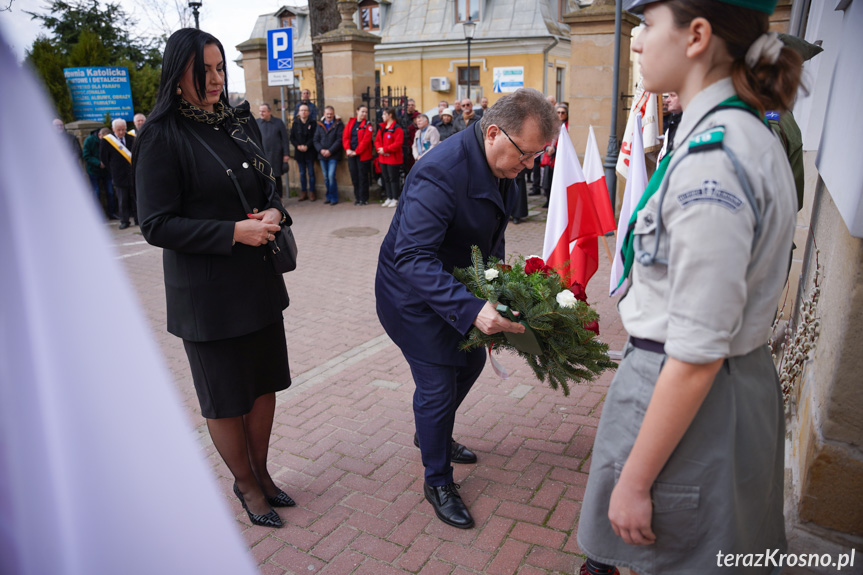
[405,349,485,486]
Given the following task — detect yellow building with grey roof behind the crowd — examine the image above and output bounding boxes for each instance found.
[237,0,571,117]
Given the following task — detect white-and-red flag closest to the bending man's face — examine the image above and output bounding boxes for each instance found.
[542,126,603,286]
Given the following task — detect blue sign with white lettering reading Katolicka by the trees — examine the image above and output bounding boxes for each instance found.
[63,66,135,122]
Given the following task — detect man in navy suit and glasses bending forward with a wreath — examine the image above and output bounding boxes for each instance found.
[375,88,557,529]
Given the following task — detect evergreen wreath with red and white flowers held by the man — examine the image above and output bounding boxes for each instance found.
[453,246,617,395]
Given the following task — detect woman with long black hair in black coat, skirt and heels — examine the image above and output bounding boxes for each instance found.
[133,28,294,527]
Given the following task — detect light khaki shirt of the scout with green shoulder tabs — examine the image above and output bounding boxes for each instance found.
[618,78,797,363]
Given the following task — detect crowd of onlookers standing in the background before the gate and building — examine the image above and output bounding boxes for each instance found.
[54,89,528,217]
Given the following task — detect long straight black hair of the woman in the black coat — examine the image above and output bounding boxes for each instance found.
[132,28,228,181]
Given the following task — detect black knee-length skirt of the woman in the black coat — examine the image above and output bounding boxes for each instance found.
[183,321,291,419]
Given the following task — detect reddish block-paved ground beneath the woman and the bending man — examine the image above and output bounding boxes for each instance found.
[111,191,625,575]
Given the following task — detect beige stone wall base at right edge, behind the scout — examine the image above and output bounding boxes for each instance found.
[792,188,863,537]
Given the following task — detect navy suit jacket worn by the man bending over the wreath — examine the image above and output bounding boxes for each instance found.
[375,123,516,365]
